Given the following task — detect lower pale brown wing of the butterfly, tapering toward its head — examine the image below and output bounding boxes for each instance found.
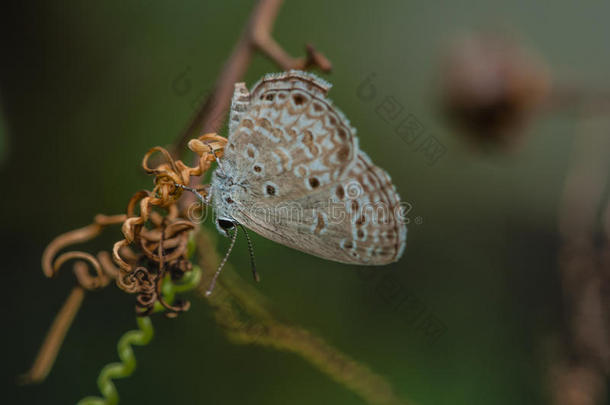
[234,152,407,265]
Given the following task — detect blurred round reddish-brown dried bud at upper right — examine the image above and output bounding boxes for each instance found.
[442,34,550,146]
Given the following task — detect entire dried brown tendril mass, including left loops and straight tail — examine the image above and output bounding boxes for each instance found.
[22,134,227,383]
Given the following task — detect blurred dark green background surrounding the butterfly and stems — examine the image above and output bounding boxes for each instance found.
[0,0,610,405]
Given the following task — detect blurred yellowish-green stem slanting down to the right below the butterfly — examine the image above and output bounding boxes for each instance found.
[197,229,406,405]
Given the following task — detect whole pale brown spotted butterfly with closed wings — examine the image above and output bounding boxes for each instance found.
[200,70,407,290]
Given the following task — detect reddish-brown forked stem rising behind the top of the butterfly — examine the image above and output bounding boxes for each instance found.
[172,0,332,156]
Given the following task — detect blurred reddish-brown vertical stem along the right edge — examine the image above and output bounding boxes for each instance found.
[552,115,610,405]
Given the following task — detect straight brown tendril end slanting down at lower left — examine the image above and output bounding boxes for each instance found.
[19,286,85,384]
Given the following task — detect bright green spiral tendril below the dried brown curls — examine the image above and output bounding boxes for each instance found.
[77,265,201,405]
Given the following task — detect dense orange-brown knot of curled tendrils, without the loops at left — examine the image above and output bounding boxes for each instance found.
[112,134,227,316]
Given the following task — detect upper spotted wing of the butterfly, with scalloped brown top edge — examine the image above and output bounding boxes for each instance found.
[223,71,358,200]
